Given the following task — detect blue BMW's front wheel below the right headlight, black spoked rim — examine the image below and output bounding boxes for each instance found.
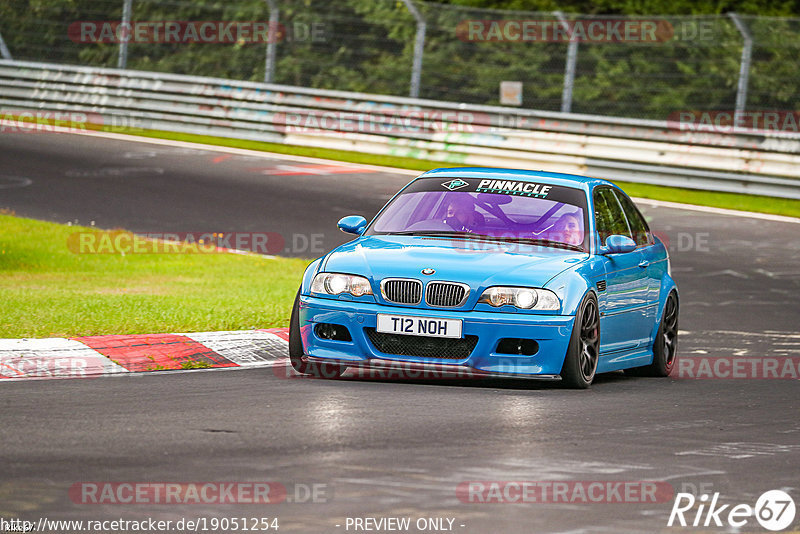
[561,292,600,389]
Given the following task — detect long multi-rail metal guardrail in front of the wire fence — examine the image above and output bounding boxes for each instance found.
[0,61,800,199]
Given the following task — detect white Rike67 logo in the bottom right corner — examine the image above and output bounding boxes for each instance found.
[667,490,796,531]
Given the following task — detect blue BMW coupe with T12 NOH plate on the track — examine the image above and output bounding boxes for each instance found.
[289,168,678,388]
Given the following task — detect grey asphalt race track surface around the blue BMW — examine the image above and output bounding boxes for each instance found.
[0,134,800,533]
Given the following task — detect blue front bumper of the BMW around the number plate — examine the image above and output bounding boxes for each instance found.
[300,296,575,378]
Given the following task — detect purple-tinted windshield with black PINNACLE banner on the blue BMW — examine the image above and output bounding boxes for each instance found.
[367,177,588,251]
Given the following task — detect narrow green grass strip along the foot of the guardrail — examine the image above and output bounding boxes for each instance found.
[125,130,800,217]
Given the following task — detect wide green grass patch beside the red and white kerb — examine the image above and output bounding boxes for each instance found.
[0,214,308,338]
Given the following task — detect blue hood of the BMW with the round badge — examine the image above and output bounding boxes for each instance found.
[323,235,588,289]
